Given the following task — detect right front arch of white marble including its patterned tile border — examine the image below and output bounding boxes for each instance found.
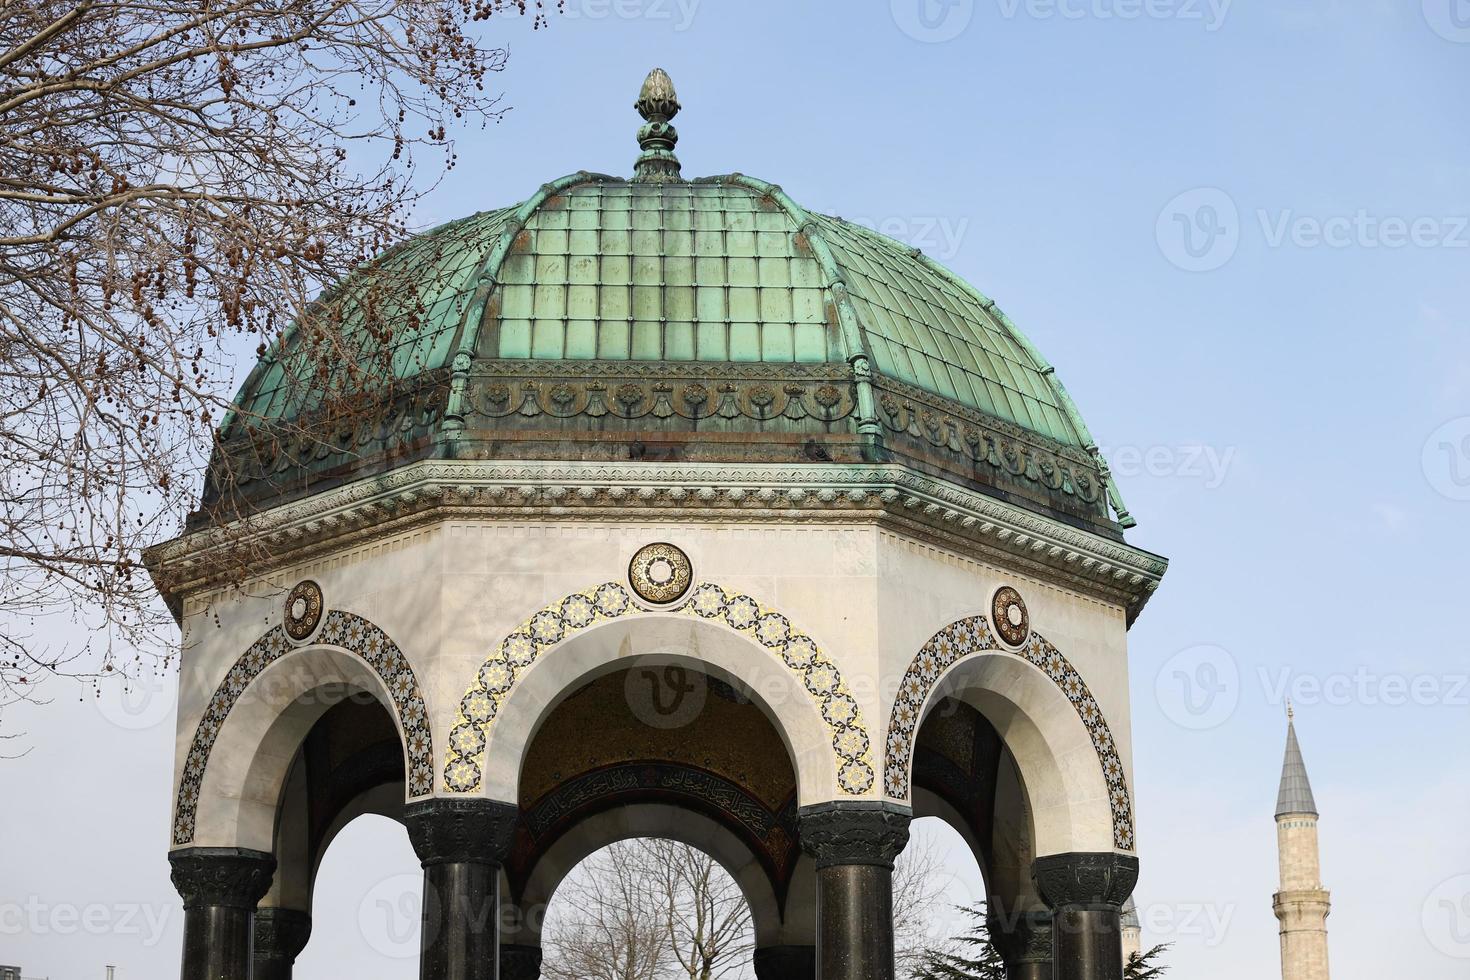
[883,616,1133,854]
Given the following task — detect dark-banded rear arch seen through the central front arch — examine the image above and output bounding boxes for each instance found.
[516,804,813,946]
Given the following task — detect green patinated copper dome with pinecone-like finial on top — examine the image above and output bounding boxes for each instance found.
[213,72,1130,537]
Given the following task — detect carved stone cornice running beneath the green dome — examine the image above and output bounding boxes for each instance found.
[144,460,1169,623]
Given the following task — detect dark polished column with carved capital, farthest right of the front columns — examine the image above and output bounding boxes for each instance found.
[1030,851,1138,980]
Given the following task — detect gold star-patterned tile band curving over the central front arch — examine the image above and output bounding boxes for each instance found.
[444,582,875,796]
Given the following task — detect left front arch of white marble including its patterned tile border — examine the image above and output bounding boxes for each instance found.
[173,610,434,851]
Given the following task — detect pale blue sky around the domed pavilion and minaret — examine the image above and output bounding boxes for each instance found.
[0,0,1470,980]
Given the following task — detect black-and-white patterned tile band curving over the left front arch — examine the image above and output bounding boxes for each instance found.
[173,610,434,845]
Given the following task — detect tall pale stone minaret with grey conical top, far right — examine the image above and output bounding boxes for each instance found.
[1274,704,1332,980]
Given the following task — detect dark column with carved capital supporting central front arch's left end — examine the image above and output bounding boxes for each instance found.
[403,799,520,980]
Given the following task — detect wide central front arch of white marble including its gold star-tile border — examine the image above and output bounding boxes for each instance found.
[444,582,875,801]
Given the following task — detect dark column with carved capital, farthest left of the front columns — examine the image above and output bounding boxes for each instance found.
[169,848,275,980]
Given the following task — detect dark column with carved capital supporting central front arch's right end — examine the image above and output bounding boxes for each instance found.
[798,802,913,980]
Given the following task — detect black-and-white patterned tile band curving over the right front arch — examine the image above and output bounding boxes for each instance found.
[883,616,1133,851]
